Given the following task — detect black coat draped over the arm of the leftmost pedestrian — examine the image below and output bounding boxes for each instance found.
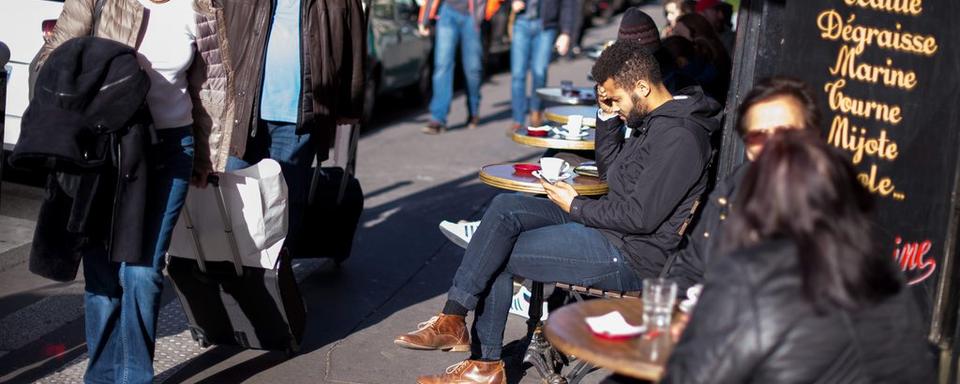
[10,37,150,281]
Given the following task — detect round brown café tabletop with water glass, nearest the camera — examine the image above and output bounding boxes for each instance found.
[544,299,673,381]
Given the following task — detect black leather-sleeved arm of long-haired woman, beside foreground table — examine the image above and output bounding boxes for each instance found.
[660,254,767,384]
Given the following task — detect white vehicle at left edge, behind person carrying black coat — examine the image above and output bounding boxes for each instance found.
[0,0,63,151]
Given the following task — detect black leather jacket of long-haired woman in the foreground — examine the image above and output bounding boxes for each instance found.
[660,239,936,384]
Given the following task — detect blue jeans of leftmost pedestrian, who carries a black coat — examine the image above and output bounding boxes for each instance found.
[83,127,193,383]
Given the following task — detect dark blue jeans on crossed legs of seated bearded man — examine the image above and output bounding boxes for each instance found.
[447,194,642,359]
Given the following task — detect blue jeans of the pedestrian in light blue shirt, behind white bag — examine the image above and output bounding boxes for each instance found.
[227,120,317,254]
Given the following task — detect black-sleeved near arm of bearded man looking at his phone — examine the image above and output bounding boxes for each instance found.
[570,127,706,234]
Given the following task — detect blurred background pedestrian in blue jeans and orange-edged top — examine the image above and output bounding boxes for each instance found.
[418,0,497,135]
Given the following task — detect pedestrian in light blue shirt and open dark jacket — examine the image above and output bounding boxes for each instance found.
[222,0,367,258]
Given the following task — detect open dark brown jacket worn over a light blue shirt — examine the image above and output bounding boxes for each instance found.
[223,0,367,158]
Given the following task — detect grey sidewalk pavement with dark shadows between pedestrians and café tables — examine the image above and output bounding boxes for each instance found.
[0,6,662,383]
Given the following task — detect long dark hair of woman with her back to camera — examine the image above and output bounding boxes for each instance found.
[723,129,902,310]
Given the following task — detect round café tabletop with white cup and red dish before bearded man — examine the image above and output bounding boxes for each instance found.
[480,163,607,196]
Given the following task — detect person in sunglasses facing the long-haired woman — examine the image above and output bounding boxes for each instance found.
[668,77,820,292]
